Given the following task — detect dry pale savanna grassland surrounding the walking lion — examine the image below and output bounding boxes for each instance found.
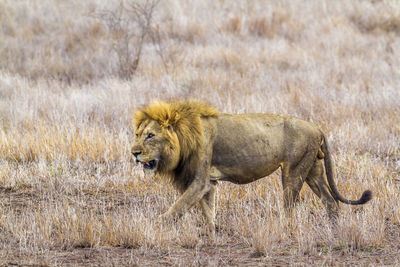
[0,0,400,266]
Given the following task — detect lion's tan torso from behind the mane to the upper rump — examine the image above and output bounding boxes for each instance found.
[212,114,320,182]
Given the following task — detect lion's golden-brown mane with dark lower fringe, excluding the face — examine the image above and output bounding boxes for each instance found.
[134,100,219,191]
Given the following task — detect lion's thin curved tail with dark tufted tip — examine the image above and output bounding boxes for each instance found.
[321,133,372,205]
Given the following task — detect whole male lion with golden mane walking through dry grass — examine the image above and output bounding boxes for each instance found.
[132,100,372,234]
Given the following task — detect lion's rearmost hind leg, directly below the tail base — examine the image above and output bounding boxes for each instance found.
[306,159,339,222]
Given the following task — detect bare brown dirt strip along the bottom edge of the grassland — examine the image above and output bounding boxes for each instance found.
[0,245,400,266]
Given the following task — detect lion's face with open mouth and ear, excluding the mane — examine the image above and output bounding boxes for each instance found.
[132,120,180,172]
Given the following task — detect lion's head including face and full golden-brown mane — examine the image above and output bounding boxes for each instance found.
[132,100,219,191]
